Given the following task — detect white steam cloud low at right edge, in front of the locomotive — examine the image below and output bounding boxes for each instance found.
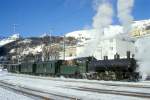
[135,37,150,80]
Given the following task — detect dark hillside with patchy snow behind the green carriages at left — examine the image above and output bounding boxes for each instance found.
[0,34,76,62]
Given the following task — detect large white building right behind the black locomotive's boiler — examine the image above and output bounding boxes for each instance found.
[93,37,135,60]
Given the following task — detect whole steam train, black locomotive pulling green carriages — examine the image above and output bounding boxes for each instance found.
[7,52,139,81]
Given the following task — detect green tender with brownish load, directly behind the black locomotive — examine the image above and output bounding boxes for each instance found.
[60,57,95,78]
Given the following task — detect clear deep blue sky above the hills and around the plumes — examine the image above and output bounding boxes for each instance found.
[0,0,150,36]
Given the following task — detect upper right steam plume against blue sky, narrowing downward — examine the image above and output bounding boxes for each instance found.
[117,0,134,33]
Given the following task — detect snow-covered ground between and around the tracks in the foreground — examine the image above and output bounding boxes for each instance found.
[0,71,150,100]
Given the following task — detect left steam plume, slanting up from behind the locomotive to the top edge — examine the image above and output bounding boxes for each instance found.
[81,0,113,56]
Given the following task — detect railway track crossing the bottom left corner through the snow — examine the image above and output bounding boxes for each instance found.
[0,81,80,100]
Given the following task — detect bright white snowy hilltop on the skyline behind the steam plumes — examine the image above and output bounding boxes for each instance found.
[66,19,150,38]
